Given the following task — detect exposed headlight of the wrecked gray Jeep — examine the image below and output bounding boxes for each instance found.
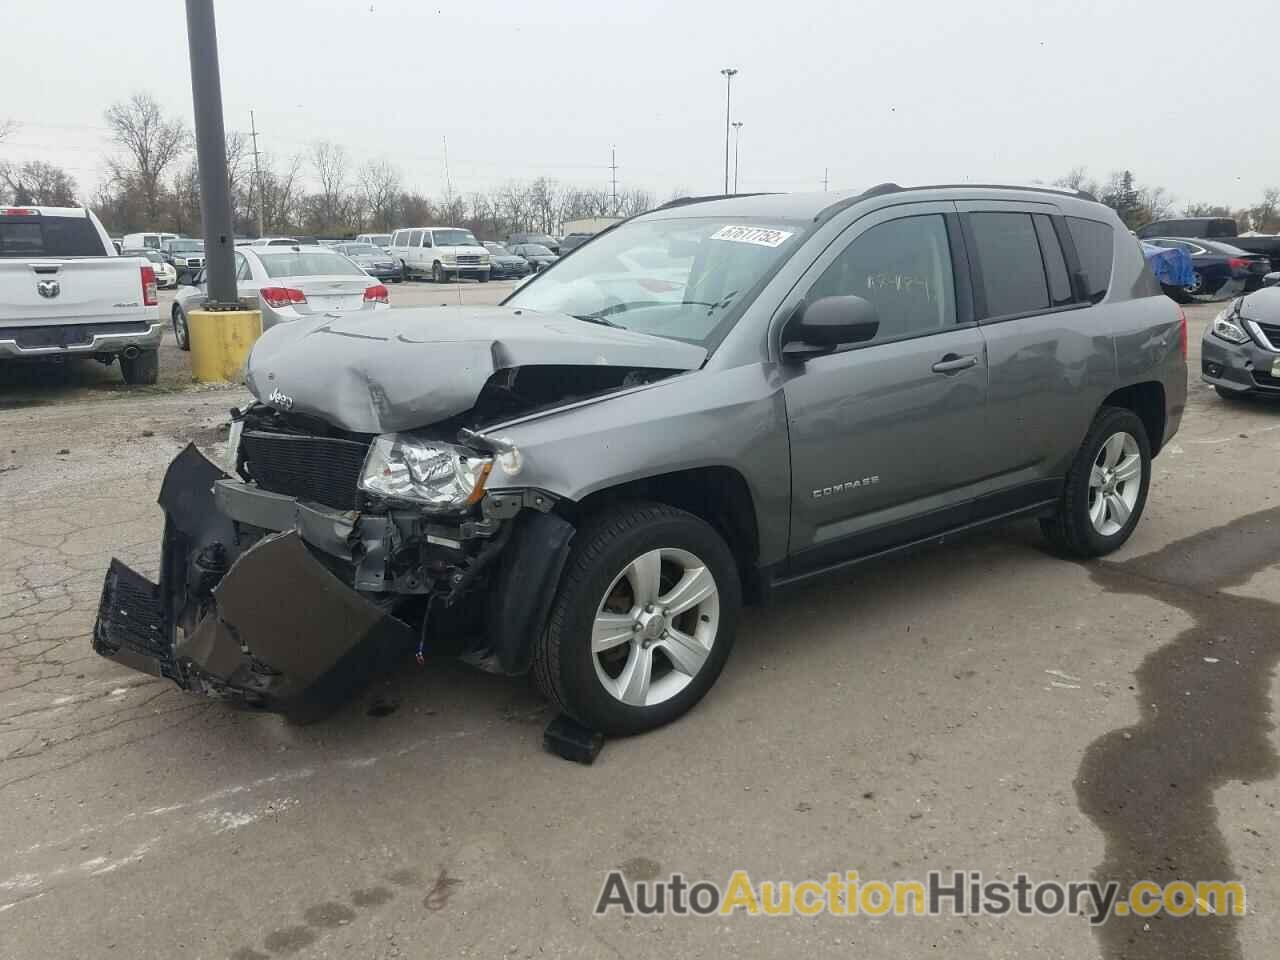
[360,434,493,512]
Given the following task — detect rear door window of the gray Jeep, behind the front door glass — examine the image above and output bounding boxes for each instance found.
[969,214,1050,316]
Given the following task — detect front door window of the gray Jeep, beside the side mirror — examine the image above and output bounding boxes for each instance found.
[808,215,956,342]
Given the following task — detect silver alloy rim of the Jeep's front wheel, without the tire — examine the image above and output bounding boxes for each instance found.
[591,547,719,707]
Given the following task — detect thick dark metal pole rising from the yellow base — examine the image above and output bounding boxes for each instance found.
[187,0,239,308]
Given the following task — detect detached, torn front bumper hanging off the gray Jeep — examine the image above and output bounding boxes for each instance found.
[93,447,415,710]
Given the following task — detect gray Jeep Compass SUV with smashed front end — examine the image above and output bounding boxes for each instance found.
[93,184,1187,733]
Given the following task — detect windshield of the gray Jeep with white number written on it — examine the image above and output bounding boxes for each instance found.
[504,218,805,346]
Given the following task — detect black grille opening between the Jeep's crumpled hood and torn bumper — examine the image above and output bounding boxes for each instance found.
[241,430,369,509]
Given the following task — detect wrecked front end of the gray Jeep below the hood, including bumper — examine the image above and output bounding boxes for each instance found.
[93,417,572,712]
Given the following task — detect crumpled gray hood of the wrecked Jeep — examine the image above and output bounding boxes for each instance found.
[246,307,707,434]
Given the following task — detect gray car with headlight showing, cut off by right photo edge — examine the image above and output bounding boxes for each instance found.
[1201,287,1280,399]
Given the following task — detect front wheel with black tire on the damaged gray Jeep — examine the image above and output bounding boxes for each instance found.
[534,503,742,736]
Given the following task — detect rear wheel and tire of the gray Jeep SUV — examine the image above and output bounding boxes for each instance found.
[1041,407,1151,558]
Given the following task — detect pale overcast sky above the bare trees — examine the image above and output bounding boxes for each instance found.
[0,0,1280,206]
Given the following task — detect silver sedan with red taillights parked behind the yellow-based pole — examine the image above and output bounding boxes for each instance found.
[172,244,390,349]
